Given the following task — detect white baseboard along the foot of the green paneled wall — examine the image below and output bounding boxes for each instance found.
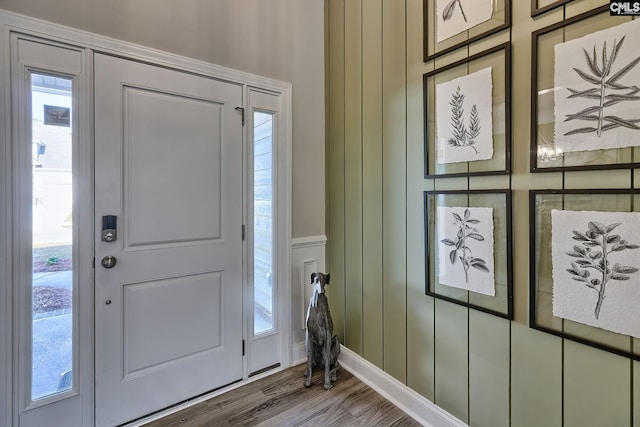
[340,346,468,427]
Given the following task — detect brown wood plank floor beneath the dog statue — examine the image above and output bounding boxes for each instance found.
[145,365,420,427]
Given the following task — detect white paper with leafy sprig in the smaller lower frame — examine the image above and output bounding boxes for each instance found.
[436,206,495,295]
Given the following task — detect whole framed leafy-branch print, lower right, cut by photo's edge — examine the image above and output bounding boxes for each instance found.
[529,189,640,360]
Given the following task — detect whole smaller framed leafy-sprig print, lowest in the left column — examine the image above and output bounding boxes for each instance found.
[424,190,513,319]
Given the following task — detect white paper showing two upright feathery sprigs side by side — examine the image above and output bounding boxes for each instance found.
[436,68,493,163]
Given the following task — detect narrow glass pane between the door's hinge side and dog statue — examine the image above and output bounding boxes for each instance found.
[253,112,273,334]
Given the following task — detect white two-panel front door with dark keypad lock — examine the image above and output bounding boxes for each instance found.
[95,54,243,426]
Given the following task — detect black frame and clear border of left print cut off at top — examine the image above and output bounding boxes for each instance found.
[423,0,512,62]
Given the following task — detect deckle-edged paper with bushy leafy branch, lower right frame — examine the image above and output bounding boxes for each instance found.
[551,210,640,337]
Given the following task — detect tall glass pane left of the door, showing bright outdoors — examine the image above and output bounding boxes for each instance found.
[31,74,73,400]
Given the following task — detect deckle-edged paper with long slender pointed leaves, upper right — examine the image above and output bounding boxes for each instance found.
[554,21,640,155]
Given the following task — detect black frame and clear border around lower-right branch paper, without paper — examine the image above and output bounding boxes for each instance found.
[529,189,640,360]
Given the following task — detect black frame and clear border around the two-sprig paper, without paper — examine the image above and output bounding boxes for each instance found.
[423,42,511,178]
